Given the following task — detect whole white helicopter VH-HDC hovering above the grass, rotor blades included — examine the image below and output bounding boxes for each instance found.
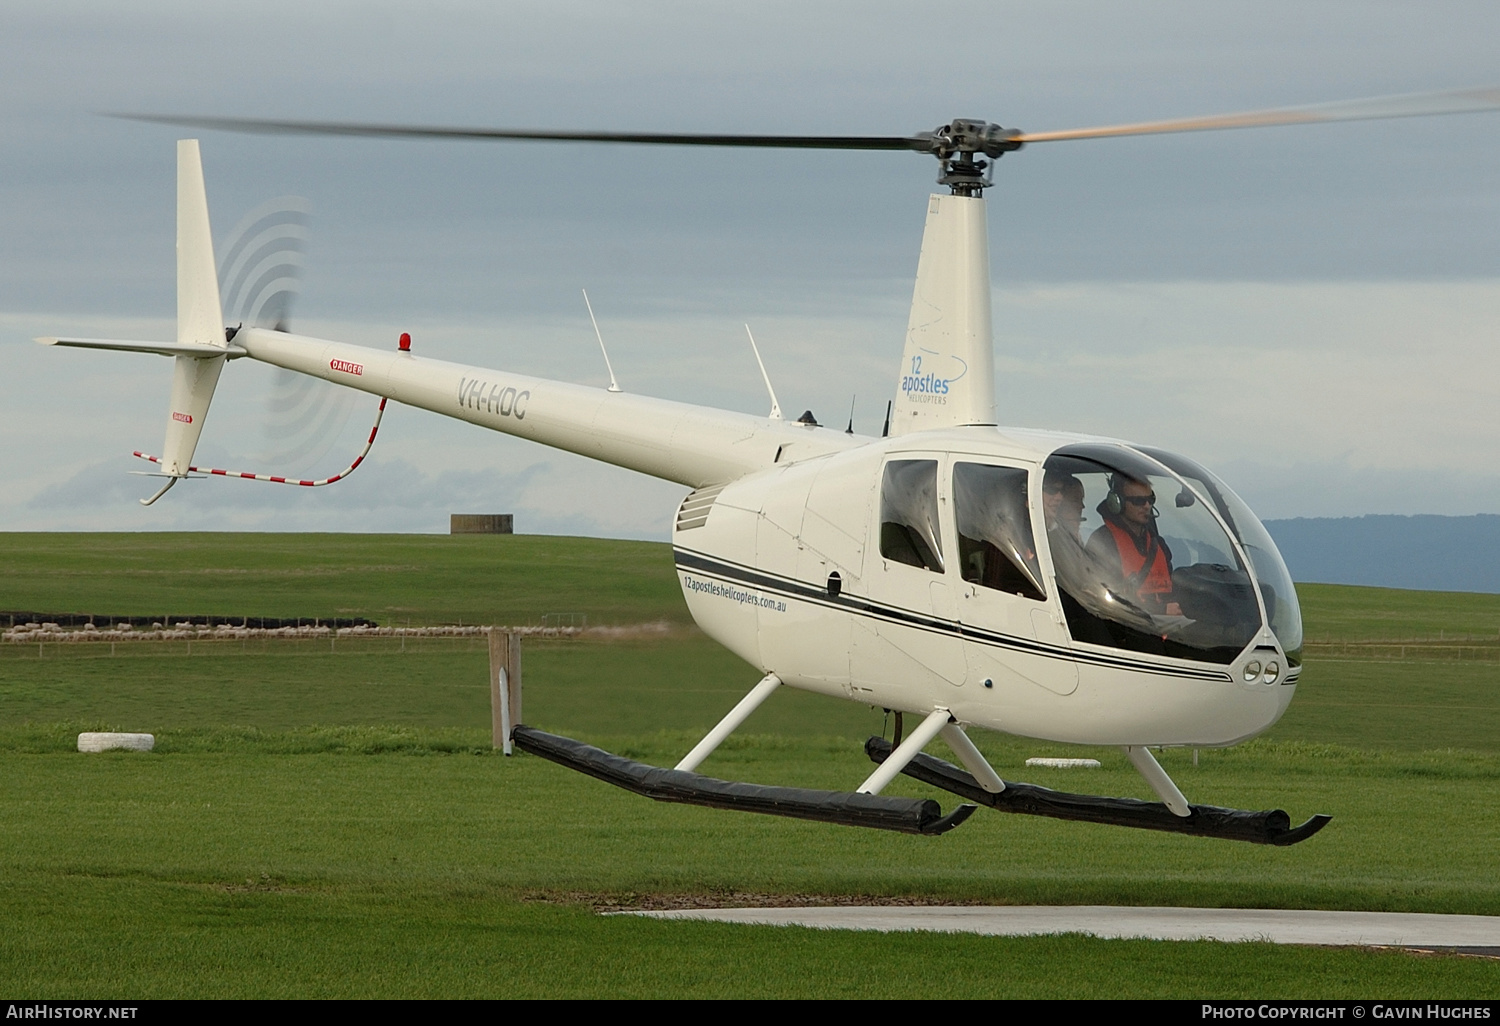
[38,89,1500,845]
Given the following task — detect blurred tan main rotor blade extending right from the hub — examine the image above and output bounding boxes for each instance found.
[1016,87,1500,143]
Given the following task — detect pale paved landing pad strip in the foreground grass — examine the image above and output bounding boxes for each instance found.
[636,905,1500,954]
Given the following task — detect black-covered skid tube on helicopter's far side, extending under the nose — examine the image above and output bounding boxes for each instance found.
[864,738,1332,846]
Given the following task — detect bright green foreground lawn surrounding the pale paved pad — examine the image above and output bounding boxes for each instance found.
[0,735,1500,998]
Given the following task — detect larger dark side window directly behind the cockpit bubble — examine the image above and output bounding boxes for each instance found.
[953,464,1047,602]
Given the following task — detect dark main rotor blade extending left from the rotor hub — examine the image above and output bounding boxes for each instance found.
[111,114,933,153]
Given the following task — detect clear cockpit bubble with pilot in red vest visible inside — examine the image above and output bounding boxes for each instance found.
[1043,443,1302,665]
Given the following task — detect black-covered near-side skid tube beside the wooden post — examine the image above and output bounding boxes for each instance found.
[510,725,975,836]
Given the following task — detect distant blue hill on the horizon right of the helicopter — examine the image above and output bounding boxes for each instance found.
[1266,513,1500,593]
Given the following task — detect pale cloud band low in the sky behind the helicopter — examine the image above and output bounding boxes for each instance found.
[0,281,1500,539]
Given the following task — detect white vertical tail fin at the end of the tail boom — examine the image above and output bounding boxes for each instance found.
[162,140,228,479]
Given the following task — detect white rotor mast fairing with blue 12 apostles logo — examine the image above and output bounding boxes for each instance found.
[891,195,995,435]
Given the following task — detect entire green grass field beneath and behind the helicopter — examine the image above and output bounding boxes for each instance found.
[0,536,1500,998]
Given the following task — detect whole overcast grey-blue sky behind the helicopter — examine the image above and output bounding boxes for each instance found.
[0,0,1500,539]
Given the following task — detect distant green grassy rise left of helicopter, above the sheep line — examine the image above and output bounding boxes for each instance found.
[0,533,690,626]
